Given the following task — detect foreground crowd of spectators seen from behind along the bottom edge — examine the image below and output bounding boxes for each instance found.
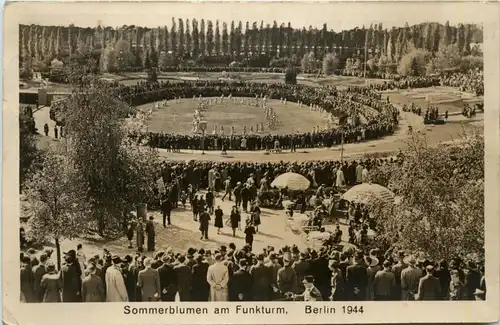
[20,235,486,303]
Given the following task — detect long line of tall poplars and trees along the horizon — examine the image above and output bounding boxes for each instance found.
[19,18,483,72]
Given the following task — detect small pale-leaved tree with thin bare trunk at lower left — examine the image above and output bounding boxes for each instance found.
[25,150,87,269]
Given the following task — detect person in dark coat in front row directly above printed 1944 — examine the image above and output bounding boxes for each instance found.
[346,252,368,301]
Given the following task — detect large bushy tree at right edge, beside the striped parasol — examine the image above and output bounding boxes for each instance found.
[370,135,484,260]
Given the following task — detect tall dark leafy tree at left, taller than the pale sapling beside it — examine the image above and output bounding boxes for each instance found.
[64,77,157,235]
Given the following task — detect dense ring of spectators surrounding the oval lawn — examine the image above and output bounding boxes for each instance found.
[119,81,398,150]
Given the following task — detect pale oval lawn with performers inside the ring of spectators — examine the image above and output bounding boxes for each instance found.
[143,99,332,134]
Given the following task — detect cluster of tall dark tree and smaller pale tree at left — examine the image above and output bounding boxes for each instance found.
[20,78,158,268]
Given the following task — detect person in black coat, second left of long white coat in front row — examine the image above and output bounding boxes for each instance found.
[61,250,82,302]
